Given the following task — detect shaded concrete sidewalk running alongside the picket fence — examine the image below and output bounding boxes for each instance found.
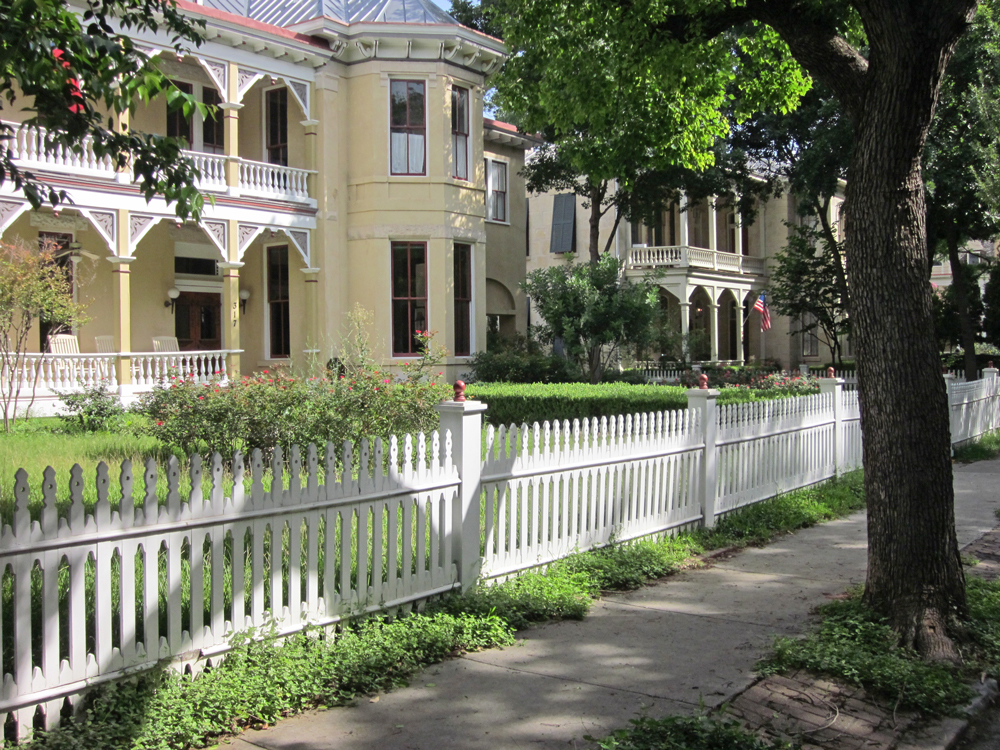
[224,460,1000,750]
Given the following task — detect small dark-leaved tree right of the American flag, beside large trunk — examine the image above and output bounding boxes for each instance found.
[770,225,850,365]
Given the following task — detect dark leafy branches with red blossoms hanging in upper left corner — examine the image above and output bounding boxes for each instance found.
[0,0,207,218]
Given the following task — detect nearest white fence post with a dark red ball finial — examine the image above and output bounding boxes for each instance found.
[434,380,487,591]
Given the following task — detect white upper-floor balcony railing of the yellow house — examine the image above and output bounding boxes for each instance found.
[4,122,314,203]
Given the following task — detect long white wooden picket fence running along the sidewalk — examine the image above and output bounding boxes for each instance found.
[0,369,1000,736]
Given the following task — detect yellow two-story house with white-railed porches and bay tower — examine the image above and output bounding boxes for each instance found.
[0,0,534,411]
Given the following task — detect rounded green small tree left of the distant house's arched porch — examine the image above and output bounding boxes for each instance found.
[524,255,657,383]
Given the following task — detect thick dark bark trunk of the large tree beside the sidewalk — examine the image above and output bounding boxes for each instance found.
[846,14,971,661]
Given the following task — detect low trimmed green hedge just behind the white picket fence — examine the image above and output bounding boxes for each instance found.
[466,383,784,427]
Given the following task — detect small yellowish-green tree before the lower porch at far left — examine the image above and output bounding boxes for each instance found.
[0,243,84,432]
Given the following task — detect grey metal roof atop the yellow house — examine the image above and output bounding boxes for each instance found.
[203,0,459,26]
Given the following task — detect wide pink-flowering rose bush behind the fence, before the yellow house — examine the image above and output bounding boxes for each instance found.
[139,333,451,460]
